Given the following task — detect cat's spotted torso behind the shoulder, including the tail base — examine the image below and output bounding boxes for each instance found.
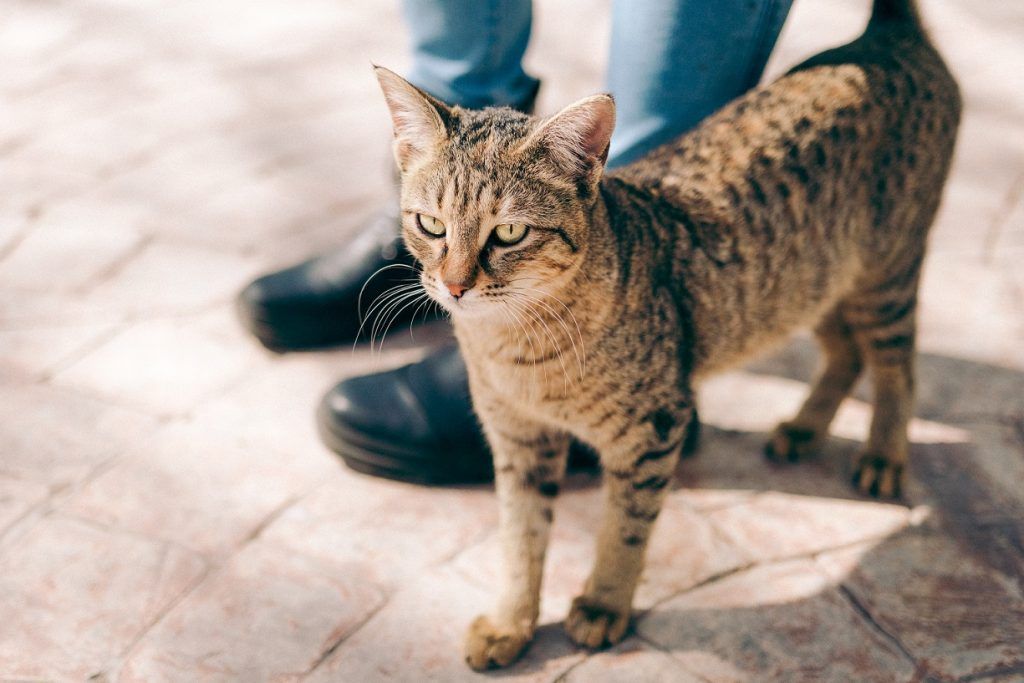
[605,0,961,368]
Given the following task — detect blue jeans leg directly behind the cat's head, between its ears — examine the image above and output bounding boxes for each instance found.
[402,0,539,109]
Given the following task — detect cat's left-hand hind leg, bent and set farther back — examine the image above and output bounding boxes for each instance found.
[765,307,862,462]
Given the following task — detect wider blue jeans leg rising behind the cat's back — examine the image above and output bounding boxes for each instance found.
[608,0,793,166]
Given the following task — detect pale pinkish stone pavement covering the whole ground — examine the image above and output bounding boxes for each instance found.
[0,0,1024,683]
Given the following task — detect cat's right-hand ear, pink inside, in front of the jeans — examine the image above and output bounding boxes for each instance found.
[523,94,615,182]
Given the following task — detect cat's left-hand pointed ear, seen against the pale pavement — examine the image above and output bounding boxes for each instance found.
[374,66,452,170]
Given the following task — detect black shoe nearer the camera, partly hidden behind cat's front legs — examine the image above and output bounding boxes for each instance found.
[316,346,699,484]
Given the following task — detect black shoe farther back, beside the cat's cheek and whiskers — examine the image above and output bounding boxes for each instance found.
[237,205,434,351]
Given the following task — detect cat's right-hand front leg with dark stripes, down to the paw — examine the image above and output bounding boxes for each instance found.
[565,409,692,648]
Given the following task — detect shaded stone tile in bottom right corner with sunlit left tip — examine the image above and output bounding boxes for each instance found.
[819,529,1024,680]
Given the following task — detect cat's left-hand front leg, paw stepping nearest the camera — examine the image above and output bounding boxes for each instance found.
[466,419,569,670]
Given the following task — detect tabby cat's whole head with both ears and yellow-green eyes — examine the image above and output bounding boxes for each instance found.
[375,67,615,318]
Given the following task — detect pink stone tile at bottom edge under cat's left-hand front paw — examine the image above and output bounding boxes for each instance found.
[305,568,584,683]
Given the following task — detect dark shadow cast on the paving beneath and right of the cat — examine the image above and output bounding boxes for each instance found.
[481,339,1024,680]
